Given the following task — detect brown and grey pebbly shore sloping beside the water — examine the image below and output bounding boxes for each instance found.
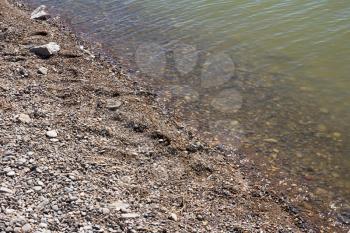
[0,0,348,232]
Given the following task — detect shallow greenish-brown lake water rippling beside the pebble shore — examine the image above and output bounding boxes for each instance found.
[30,0,350,218]
